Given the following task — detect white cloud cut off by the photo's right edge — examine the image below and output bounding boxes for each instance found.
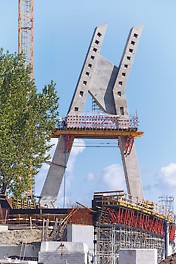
[161,163,176,187]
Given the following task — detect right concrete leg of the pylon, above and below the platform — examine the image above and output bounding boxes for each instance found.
[113,25,144,198]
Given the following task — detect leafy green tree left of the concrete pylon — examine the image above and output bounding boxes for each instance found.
[0,50,59,198]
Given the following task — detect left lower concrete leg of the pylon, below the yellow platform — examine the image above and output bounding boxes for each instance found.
[40,135,73,208]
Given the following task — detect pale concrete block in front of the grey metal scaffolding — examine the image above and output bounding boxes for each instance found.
[119,249,157,264]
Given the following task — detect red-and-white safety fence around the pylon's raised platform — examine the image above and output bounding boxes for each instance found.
[58,115,139,129]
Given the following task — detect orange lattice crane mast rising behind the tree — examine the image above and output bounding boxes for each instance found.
[18,0,34,79]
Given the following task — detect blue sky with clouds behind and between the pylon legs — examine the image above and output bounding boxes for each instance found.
[0,0,176,209]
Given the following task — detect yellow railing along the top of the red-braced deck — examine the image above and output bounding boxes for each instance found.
[102,194,175,223]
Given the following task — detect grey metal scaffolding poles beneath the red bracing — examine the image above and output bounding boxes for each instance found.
[94,225,164,264]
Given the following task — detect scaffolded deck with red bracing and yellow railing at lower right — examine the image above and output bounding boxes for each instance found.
[93,190,175,264]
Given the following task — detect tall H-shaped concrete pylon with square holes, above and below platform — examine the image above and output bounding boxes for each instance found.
[40,24,143,207]
